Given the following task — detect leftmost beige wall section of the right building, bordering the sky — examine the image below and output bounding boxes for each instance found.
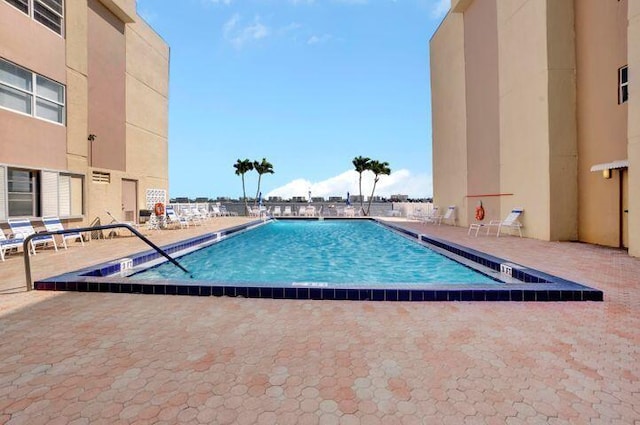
[430,13,467,225]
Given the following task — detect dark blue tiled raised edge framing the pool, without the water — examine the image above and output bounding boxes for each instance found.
[34,217,604,301]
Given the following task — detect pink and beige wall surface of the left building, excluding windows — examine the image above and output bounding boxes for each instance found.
[0,0,169,224]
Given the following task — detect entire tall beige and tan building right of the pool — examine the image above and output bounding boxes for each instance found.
[430,0,640,256]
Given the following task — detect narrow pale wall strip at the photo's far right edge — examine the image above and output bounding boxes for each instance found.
[627,0,640,257]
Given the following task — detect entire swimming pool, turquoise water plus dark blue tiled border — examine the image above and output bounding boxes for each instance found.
[35,219,603,301]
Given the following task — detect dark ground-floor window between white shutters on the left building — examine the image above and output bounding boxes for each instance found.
[7,168,38,217]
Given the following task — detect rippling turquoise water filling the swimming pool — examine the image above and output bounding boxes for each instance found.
[135,220,498,285]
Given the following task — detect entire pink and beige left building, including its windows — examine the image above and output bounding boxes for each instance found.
[0,0,169,227]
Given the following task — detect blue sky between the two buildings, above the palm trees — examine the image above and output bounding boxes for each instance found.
[138,0,449,198]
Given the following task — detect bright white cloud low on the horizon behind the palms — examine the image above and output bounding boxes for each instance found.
[266,169,433,199]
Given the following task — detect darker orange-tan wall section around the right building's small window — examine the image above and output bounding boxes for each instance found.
[576,0,628,247]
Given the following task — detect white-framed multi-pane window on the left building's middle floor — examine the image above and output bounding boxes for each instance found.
[0,59,65,124]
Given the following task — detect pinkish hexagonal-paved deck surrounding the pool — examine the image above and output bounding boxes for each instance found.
[0,218,640,425]
